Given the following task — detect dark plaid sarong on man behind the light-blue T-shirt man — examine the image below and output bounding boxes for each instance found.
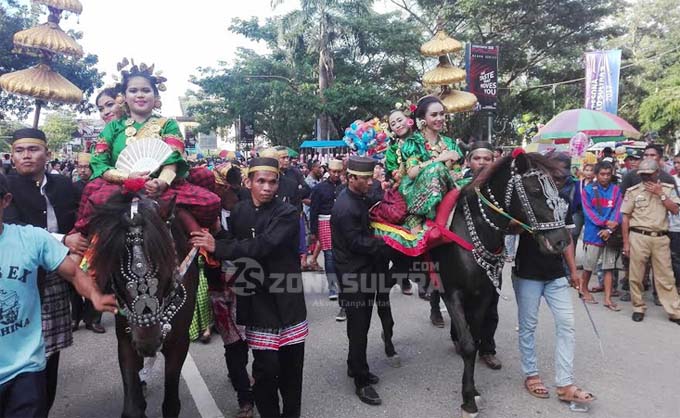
[40,272,73,358]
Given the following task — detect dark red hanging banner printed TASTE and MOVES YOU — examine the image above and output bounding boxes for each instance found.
[465,43,498,110]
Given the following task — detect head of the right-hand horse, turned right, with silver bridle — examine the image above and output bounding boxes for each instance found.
[506,153,570,254]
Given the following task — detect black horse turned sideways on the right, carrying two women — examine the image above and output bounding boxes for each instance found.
[430,153,570,417]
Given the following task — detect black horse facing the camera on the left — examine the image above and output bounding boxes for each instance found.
[91,193,198,417]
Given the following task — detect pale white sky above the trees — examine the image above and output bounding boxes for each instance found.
[23,0,298,116]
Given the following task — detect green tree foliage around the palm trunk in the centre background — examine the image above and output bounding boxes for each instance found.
[191,9,423,147]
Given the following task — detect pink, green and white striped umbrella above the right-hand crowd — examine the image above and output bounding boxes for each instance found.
[532,109,640,144]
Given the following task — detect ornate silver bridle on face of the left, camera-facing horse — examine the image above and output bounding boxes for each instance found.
[113,198,187,339]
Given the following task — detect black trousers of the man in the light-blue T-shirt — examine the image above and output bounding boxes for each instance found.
[0,370,47,418]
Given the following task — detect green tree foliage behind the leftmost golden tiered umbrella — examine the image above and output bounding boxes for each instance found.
[0,0,104,119]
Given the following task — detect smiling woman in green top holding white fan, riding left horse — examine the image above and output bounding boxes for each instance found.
[76,62,220,235]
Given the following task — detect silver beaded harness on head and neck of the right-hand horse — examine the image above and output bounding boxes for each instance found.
[463,161,567,295]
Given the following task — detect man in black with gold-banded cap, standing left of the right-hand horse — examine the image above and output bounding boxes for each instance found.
[331,156,388,405]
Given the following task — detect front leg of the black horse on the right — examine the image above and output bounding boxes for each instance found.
[443,289,479,416]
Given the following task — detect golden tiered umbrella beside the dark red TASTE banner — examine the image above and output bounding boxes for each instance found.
[420,31,477,113]
